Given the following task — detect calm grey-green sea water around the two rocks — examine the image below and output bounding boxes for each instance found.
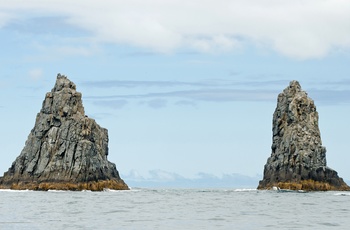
[0,188,350,230]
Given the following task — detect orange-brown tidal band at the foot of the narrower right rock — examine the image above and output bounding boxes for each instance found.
[258,180,350,191]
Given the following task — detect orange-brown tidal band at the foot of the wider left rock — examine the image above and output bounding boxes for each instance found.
[0,180,129,191]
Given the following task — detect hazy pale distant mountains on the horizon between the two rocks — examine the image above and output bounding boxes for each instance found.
[122,170,262,188]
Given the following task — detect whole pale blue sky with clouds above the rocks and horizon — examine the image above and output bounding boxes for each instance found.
[0,0,350,182]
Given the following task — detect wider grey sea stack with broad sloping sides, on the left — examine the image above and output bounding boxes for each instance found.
[0,74,129,191]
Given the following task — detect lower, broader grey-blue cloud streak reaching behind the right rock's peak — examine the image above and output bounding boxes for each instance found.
[86,88,350,109]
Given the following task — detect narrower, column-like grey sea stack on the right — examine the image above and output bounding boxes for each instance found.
[258,81,349,191]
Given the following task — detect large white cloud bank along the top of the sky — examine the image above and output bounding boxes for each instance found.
[0,0,350,59]
